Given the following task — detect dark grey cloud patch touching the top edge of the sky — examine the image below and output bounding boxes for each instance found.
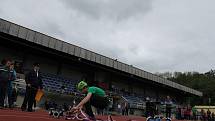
[60,0,153,21]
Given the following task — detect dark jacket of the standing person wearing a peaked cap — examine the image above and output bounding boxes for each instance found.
[25,70,43,89]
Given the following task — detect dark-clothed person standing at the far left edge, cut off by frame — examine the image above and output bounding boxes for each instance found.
[0,59,12,109]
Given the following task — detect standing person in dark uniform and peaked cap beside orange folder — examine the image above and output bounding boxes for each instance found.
[21,63,43,112]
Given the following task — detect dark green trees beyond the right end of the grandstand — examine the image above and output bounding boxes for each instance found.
[156,70,215,105]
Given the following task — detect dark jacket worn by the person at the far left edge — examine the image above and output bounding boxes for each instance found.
[0,66,12,85]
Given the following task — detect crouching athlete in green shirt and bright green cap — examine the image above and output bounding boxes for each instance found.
[72,81,109,119]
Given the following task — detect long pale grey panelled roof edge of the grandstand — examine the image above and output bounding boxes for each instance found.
[0,18,203,96]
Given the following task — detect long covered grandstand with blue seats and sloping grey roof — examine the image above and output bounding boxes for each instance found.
[0,19,203,115]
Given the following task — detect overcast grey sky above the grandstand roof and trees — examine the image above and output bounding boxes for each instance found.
[0,0,215,72]
